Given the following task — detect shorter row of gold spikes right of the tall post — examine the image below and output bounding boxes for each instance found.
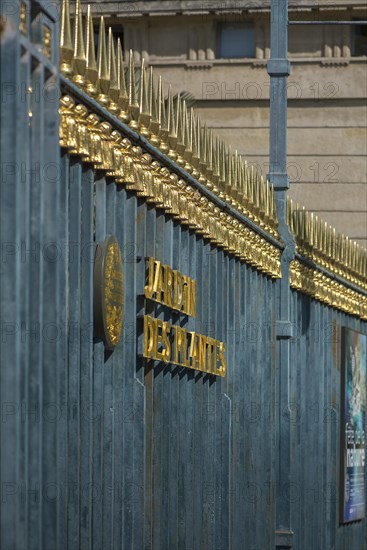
[287,197,367,287]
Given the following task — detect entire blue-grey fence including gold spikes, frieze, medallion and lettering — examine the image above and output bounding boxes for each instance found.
[0,0,367,550]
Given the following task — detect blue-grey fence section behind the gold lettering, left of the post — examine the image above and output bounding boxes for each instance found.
[60,168,275,548]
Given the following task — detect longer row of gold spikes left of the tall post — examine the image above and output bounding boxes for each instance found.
[60,0,277,235]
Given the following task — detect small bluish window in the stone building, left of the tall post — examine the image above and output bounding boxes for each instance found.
[218,22,256,59]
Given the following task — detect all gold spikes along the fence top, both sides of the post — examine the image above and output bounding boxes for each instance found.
[60,0,367,294]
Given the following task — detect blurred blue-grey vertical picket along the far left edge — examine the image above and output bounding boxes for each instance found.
[0,2,21,548]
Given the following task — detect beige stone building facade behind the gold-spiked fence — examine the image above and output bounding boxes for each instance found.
[88,0,367,246]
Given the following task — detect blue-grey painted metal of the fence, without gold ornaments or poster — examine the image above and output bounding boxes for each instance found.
[0,2,367,550]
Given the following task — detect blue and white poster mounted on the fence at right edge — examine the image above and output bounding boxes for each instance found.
[340,327,366,523]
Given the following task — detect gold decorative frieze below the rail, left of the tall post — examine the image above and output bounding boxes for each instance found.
[60,96,280,278]
